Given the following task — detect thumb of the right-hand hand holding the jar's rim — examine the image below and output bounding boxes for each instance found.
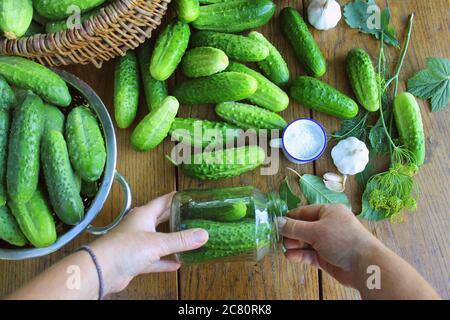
[277,217,316,245]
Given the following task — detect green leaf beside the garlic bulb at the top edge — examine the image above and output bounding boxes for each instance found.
[344,0,400,47]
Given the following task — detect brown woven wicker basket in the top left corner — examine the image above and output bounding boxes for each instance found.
[0,0,171,68]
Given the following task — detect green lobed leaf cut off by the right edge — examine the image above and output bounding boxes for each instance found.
[408,58,450,112]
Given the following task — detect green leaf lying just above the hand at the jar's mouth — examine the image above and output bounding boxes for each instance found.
[300,174,352,208]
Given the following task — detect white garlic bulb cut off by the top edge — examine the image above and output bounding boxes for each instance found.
[308,0,342,30]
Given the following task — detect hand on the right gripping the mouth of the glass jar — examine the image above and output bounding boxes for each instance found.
[278,204,383,287]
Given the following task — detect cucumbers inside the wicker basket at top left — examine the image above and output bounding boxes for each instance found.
[0,0,114,39]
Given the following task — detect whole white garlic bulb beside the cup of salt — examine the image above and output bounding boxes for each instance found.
[331,137,369,176]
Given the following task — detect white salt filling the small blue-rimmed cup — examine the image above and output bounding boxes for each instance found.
[284,120,325,160]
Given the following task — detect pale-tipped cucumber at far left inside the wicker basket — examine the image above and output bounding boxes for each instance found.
[0,0,33,39]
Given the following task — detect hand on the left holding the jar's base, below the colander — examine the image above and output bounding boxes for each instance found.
[91,193,208,293]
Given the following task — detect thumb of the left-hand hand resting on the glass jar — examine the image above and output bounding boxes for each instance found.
[159,229,209,257]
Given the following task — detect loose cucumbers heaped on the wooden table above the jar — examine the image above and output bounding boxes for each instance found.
[114,0,378,180]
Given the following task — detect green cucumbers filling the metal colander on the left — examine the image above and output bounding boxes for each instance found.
[0,56,106,248]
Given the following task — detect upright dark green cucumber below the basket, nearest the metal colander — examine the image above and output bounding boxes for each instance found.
[114,51,139,129]
